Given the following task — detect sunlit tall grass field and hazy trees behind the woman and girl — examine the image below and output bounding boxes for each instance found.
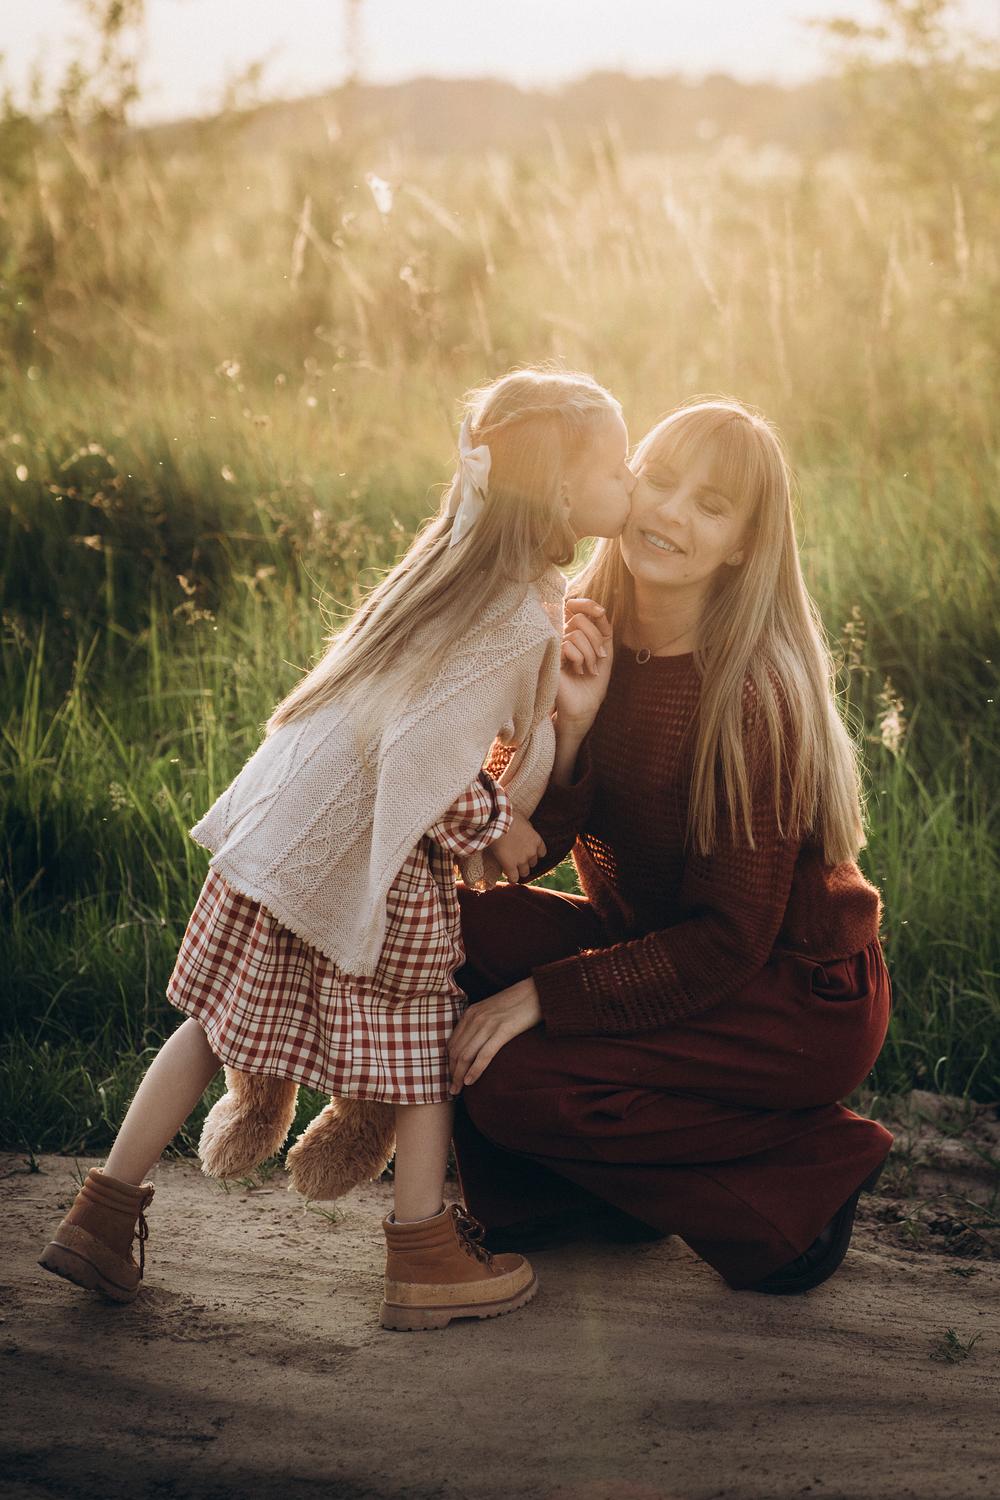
[0,3,1000,1154]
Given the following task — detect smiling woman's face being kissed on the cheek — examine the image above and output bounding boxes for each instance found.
[621,453,748,594]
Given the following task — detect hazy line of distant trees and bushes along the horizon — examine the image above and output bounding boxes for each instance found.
[0,0,1000,363]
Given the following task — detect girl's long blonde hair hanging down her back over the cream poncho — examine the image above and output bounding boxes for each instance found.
[267,368,621,734]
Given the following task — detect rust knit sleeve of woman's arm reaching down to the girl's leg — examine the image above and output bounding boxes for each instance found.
[534,750,801,1037]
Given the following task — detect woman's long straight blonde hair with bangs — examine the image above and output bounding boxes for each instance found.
[573,398,864,864]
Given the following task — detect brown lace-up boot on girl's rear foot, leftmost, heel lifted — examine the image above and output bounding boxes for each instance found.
[39,1167,153,1302]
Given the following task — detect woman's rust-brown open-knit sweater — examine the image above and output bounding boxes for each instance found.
[532,648,879,1037]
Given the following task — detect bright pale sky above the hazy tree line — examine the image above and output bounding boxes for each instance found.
[0,0,1000,119]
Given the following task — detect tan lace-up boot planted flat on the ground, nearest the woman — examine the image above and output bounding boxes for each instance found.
[381,1203,538,1332]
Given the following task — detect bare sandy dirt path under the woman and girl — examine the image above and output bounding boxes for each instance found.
[0,1095,1000,1500]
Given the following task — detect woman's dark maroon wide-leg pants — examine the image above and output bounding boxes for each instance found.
[456,885,892,1287]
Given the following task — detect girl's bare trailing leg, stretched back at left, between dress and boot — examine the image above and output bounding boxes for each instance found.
[103,1017,220,1184]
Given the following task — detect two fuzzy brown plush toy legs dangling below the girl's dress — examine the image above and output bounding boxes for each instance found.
[198,1068,396,1200]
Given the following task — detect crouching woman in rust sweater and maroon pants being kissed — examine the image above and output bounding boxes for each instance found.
[450,401,892,1293]
